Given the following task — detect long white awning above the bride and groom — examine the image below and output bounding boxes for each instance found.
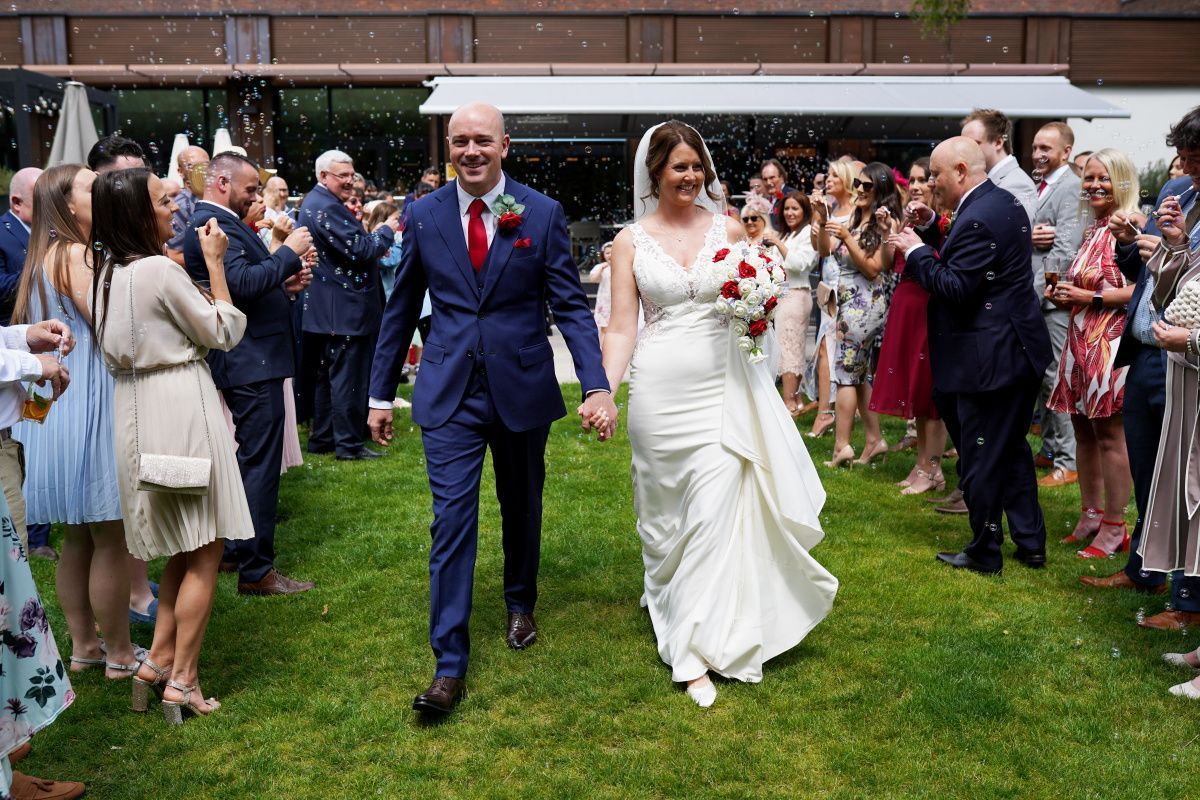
[420,76,1129,119]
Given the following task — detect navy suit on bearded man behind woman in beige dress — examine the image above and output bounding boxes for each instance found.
[182,203,301,583]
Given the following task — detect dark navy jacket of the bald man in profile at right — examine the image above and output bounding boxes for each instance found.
[905,180,1051,393]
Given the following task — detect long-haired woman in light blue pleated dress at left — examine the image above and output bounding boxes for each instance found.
[13,164,145,679]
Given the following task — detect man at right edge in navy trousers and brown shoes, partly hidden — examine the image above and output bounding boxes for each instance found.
[1079,107,1200,630]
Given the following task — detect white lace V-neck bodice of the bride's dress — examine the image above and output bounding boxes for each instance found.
[630,215,728,326]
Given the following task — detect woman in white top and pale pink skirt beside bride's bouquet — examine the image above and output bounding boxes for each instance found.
[772,192,818,416]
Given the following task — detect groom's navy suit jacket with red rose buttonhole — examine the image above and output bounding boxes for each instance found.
[371,175,610,432]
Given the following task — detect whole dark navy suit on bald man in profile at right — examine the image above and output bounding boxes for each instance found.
[905,180,1051,569]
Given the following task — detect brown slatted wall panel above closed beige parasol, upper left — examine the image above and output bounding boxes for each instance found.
[67,17,226,64]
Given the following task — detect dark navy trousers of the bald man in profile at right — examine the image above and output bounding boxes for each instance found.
[934,375,1046,569]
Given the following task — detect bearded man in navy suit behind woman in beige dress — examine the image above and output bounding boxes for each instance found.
[182,152,313,595]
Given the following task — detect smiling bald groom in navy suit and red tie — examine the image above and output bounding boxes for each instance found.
[368,103,617,714]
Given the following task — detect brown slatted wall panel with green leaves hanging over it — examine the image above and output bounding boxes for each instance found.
[872,17,1025,64]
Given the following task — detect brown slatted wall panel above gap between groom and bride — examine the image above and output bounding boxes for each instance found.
[475,14,628,64]
